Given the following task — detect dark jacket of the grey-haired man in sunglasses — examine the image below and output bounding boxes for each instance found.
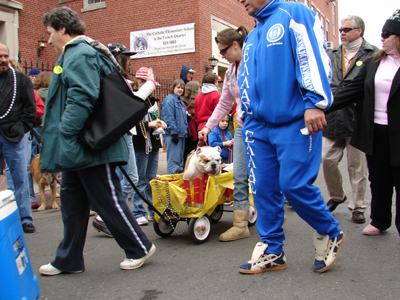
[323,40,378,138]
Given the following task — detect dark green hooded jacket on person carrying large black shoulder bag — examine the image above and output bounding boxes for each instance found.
[40,40,129,173]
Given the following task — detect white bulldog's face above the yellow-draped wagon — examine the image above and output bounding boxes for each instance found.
[195,147,222,175]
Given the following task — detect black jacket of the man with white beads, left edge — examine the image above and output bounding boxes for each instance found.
[0,68,36,143]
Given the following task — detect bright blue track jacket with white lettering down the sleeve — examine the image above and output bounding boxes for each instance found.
[239,0,333,126]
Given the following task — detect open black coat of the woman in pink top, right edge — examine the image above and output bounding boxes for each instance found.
[329,58,400,167]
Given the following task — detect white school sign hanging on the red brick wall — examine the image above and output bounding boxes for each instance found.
[130,23,195,59]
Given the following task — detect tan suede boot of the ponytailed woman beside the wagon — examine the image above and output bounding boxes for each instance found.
[219,209,250,242]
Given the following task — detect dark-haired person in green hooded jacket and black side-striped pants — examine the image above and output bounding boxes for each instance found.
[39,7,156,275]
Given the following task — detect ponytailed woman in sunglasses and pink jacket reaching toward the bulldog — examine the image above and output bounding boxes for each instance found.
[198,26,250,242]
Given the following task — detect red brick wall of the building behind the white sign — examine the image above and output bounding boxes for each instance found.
[19,0,338,81]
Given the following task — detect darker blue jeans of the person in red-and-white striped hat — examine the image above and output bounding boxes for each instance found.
[132,149,159,219]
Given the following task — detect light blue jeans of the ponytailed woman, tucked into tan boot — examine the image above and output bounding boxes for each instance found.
[233,125,250,210]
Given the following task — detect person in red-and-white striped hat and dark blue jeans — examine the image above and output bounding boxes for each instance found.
[132,67,167,225]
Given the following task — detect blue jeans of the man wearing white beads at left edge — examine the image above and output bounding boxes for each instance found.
[0,134,32,224]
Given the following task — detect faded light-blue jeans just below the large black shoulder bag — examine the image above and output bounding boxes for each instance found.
[116,134,138,203]
